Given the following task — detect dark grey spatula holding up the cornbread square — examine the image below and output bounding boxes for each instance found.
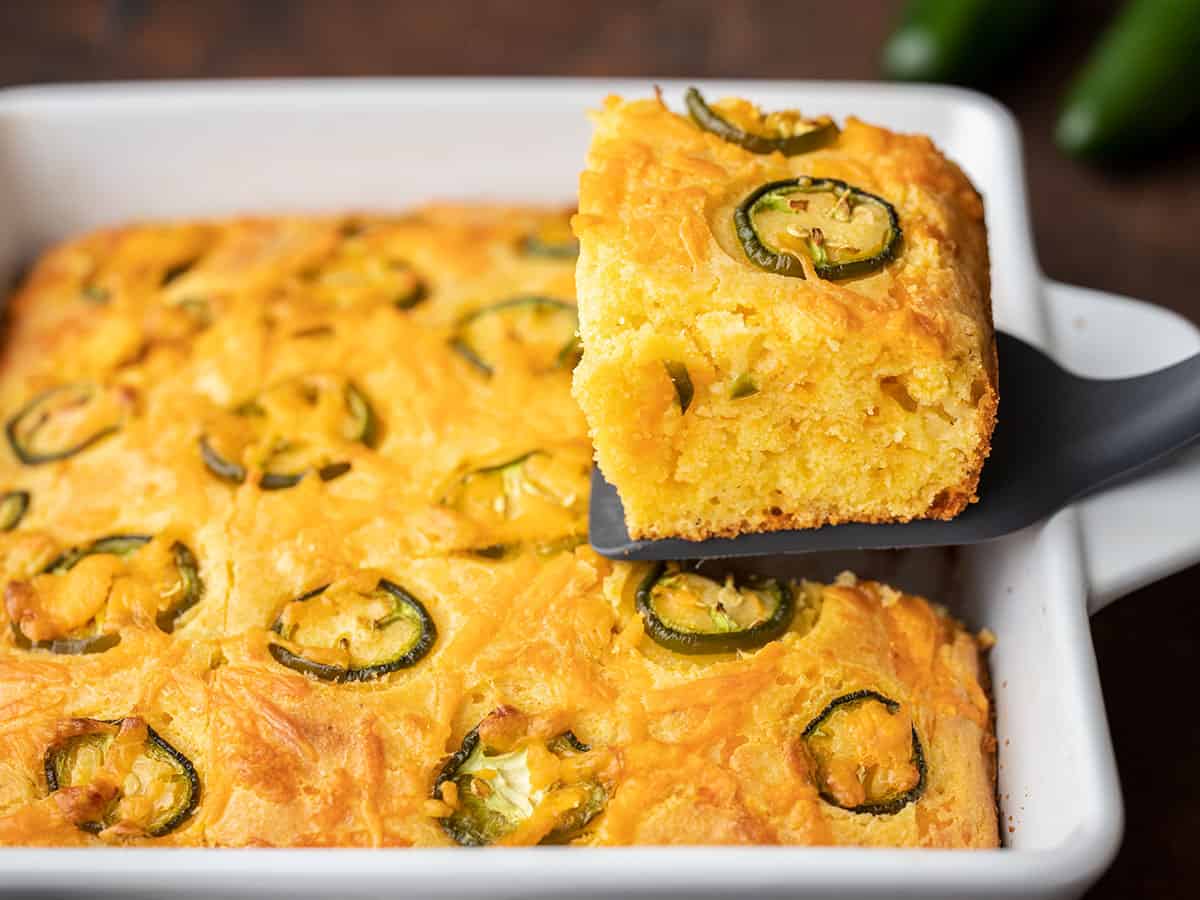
[589,332,1200,559]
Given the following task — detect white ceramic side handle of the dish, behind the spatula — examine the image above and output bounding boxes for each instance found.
[1045,282,1200,612]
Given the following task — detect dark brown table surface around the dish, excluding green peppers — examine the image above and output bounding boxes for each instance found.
[0,0,1200,900]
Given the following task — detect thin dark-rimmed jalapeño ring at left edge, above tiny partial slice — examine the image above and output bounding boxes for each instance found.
[5,382,125,466]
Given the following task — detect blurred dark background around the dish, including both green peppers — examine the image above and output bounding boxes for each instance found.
[0,0,1200,900]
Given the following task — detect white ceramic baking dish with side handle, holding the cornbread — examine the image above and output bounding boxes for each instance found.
[0,80,1200,898]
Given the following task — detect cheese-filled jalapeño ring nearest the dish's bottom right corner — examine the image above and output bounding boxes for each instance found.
[800,690,926,816]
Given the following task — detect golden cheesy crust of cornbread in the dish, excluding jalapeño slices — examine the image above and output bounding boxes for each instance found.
[0,206,996,847]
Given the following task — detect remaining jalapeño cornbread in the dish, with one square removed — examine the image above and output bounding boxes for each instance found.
[0,206,997,847]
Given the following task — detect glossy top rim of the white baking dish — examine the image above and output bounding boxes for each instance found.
[0,77,1123,896]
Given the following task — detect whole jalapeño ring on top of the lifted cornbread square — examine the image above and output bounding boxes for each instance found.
[733,175,901,281]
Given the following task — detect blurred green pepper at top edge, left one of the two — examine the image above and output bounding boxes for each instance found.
[882,0,1055,84]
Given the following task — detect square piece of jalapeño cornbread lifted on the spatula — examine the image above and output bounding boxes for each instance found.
[575,90,997,540]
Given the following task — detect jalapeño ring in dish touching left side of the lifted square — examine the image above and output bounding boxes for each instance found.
[450,295,580,377]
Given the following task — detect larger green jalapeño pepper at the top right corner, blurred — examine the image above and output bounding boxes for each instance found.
[1055,0,1200,158]
